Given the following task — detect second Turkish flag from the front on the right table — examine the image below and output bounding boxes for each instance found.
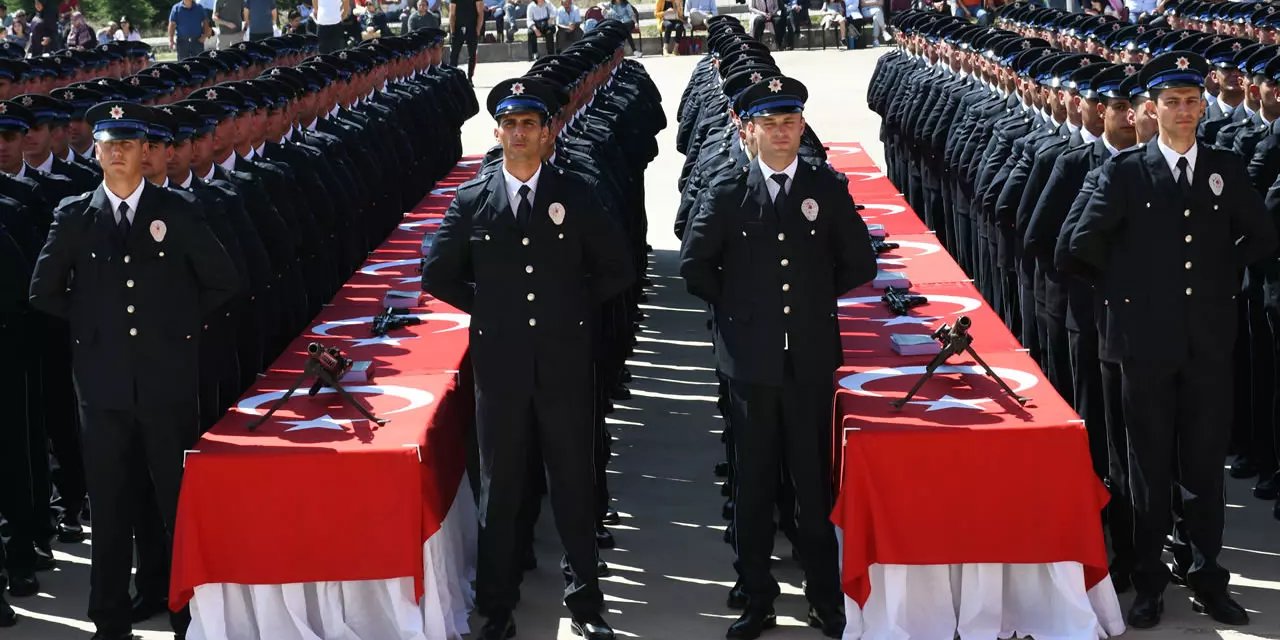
[838,283,1021,362]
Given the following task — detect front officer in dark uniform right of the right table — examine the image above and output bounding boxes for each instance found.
[1069,50,1276,628]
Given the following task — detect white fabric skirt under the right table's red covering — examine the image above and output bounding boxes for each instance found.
[844,562,1125,640]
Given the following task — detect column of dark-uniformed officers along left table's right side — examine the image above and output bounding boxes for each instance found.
[422,20,664,640]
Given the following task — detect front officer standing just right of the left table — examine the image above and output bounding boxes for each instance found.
[422,78,635,640]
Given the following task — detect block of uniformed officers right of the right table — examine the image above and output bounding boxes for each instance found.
[868,0,1280,628]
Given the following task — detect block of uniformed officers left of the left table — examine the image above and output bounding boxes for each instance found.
[0,24,479,639]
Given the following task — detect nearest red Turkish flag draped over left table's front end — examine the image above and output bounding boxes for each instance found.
[169,375,470,607]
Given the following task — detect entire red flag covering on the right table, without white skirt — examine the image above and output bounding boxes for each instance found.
[828,143,1108,605]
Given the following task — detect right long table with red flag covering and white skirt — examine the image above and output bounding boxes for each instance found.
[828,143,1125,640]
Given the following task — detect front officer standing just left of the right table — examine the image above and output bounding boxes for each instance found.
[680,76,876,639]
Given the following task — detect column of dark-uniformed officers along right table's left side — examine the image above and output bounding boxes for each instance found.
[675,13,876,639]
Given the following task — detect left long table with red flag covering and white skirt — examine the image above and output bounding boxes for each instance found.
[169,157,479,640]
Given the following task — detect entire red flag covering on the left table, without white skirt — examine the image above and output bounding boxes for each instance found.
[169,159,479,609]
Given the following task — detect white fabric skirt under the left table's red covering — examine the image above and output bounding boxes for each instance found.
[187,474,479,640]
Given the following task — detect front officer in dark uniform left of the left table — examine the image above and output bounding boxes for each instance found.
[31,102,239,640]
